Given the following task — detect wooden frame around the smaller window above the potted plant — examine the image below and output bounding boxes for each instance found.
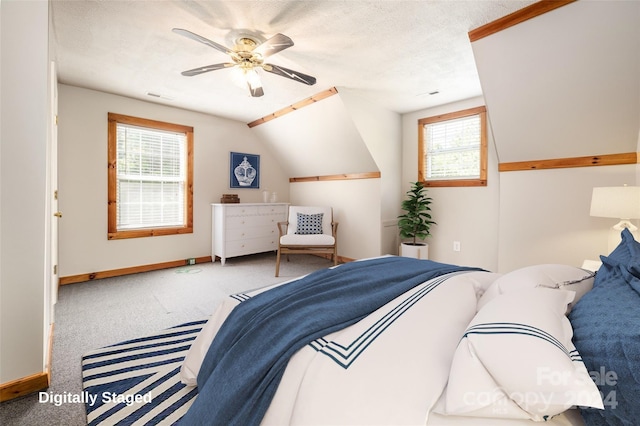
[418,106,487,187]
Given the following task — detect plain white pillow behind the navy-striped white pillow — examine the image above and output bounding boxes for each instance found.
[477,263,595,313]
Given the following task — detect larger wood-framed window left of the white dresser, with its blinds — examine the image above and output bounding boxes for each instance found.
[108,113,193,239]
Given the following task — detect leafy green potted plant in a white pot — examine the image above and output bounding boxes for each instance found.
[398,182,435,259]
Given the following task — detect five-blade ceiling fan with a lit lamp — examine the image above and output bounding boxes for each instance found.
[172,28,316,97]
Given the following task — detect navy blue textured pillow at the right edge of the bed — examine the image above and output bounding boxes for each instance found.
[569,229,640,426]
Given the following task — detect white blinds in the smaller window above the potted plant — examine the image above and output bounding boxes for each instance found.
[422,115,481,180]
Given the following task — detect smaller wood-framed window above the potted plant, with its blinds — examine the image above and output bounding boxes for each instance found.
[418,106,487,186]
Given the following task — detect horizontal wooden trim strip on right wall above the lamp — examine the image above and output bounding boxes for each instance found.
[498,152,639,172]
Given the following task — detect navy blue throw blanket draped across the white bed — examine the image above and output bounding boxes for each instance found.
[182,257,478,426]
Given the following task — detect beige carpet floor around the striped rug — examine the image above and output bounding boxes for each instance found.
[0,253,332,426]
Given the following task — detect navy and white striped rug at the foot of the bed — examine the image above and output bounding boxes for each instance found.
[82,320,206,425]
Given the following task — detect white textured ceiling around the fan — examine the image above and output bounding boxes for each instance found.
[51,0,534,122]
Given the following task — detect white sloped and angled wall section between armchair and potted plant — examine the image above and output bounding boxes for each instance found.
[252,88,401,259]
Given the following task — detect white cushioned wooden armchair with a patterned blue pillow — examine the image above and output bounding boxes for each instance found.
[276,206,338,277]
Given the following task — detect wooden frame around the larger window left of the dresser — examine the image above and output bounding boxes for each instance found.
[107,112,193,240]
